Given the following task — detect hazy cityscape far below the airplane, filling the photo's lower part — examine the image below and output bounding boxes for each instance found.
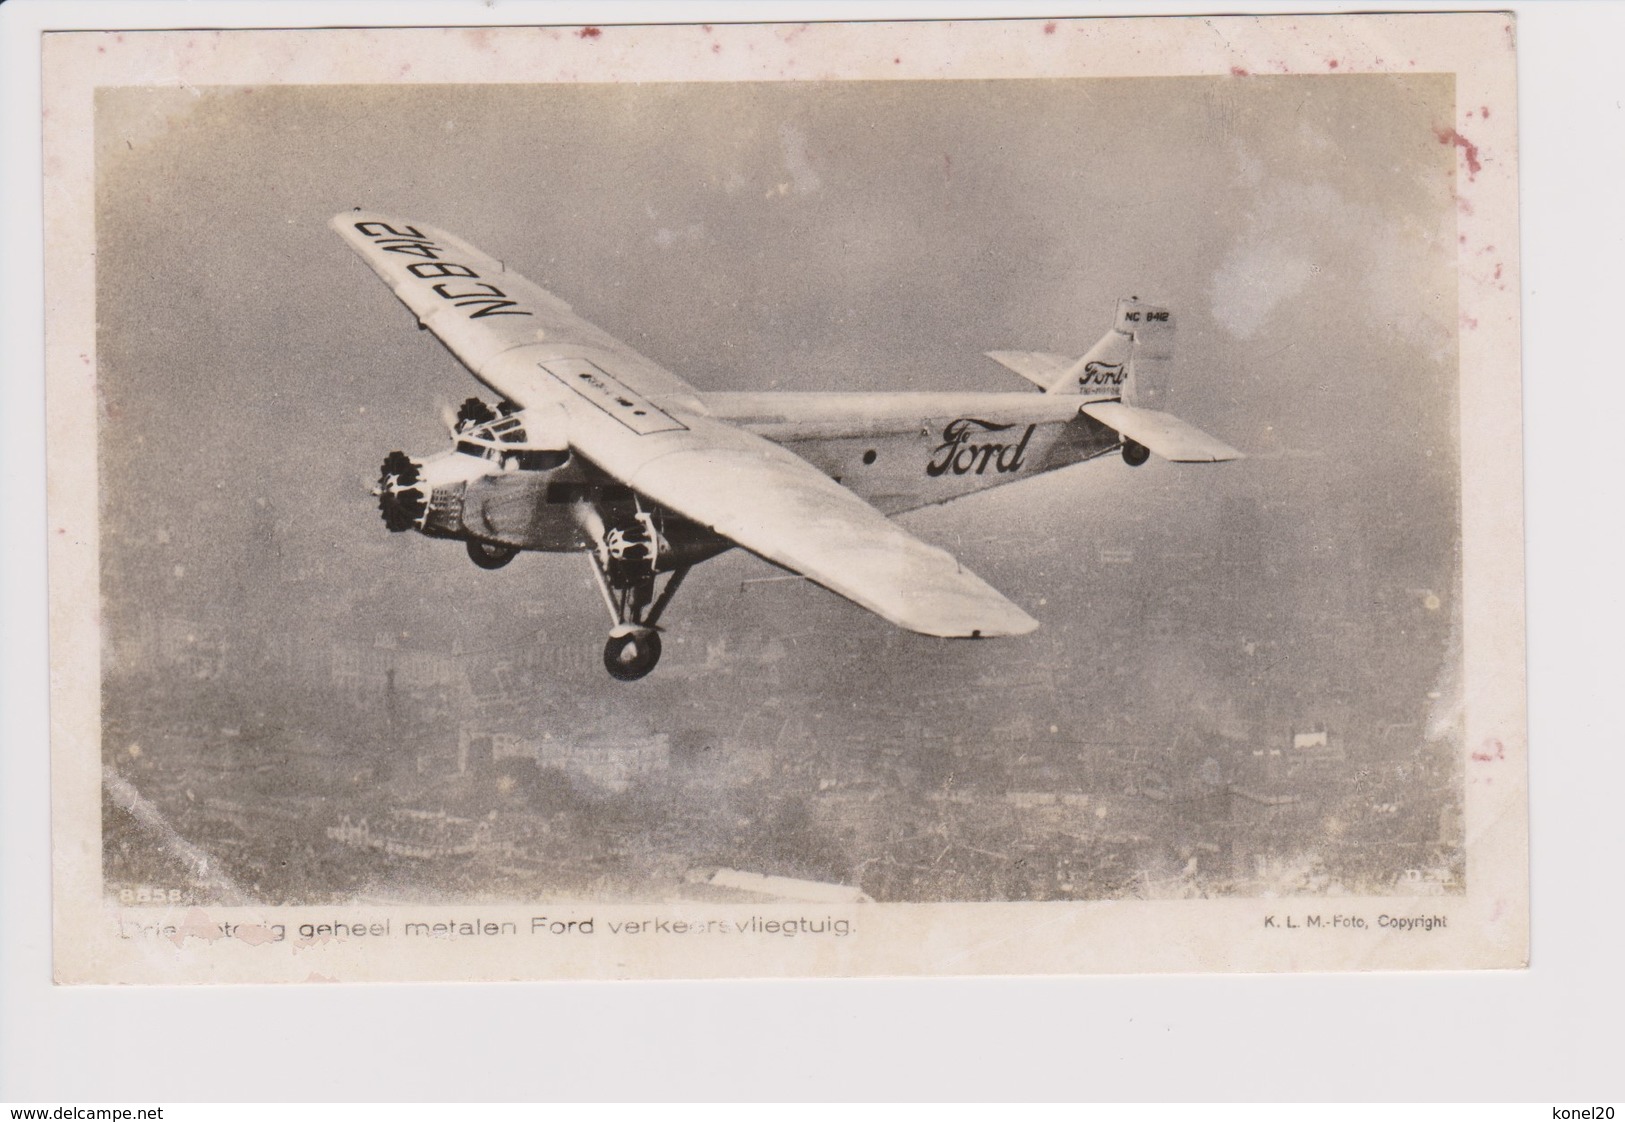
[104,455,1464,904]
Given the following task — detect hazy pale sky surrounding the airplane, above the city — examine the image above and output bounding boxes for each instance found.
[98,75,1456,728]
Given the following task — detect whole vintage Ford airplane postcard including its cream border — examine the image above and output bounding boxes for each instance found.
[44,13,1528,984]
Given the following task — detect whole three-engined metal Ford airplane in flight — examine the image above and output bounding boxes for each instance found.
[332,210,1240,681]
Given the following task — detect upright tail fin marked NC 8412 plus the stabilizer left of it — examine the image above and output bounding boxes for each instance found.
[988,298,1173,405]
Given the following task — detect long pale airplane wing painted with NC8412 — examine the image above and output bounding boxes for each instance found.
[332,211,1038,637]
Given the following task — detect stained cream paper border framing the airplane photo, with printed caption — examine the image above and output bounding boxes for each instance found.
[44,15,1528,982]
